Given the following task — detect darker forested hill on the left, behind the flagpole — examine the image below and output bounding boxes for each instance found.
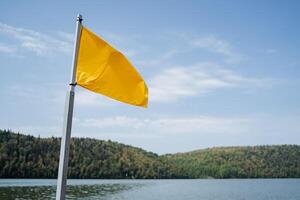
[0,131,167,178]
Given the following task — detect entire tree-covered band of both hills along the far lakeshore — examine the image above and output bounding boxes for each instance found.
[0,130,300,179]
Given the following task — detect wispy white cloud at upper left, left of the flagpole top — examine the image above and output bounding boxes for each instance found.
[0,22,72,56]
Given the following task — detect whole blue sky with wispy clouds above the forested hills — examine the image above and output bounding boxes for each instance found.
[0,0,300,154]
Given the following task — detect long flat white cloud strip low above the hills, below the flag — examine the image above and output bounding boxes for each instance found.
[78,116,252,134]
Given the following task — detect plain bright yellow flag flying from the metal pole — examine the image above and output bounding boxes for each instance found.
[77,26,148,107]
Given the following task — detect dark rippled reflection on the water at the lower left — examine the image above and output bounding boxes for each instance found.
[0,184,133,200]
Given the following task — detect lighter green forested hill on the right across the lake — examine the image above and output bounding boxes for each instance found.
[164,145,300,178]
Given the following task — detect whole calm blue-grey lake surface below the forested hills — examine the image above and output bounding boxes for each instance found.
[0,179,300,200]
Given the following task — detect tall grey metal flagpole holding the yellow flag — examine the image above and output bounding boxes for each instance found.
[56,14,82,200]
